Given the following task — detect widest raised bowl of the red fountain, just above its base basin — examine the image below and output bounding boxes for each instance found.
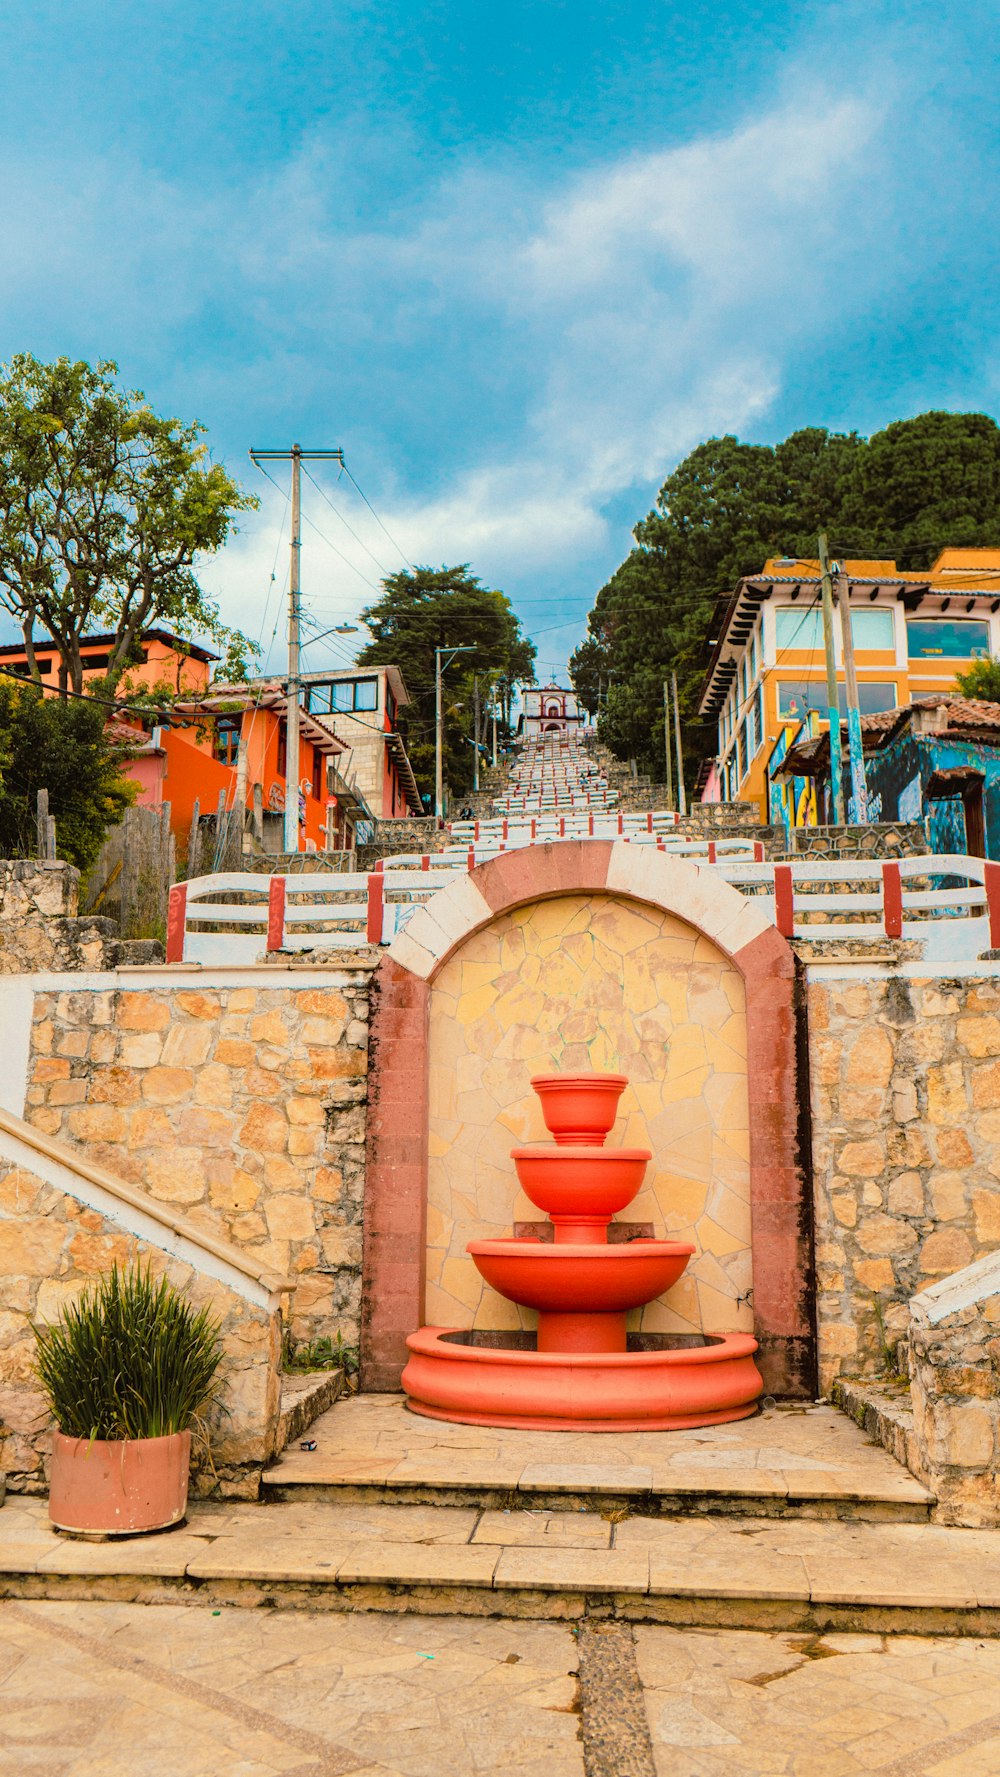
[465,1239,694,1313]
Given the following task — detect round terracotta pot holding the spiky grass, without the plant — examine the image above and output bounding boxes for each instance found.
[48,1432,192,1537]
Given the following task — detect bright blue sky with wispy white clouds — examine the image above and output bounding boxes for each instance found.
[0,0,1000,670]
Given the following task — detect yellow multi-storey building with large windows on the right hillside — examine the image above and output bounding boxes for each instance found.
[698,549,1000,819]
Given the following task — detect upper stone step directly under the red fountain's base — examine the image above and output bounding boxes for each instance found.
[263,1395,934,1523]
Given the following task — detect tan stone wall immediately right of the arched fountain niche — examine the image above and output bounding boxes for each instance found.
[806,970,1000,1390]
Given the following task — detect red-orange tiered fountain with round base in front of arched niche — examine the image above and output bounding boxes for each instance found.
[403,1073,762,1430]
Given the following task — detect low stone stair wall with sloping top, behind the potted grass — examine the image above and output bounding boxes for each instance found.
[0,1157,281,1498]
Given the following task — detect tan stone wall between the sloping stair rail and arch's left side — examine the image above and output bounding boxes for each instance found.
[25,968,371,1340]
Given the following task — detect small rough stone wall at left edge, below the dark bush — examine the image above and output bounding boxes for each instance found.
[0,858,117,976]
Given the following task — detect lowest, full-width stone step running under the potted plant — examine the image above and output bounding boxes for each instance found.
[0,1496,1000,1635]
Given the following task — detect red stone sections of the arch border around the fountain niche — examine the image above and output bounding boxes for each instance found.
[361,841,815,1398]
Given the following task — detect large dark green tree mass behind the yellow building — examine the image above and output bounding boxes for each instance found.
[570,412,1000,777]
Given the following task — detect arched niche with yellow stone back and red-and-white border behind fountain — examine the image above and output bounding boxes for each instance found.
[361,841,815,1398]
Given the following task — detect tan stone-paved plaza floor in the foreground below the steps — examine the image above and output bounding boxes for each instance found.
[0,1599,1000,1777]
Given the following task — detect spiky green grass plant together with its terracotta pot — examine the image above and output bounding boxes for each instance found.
[34,1265,222,1535]
